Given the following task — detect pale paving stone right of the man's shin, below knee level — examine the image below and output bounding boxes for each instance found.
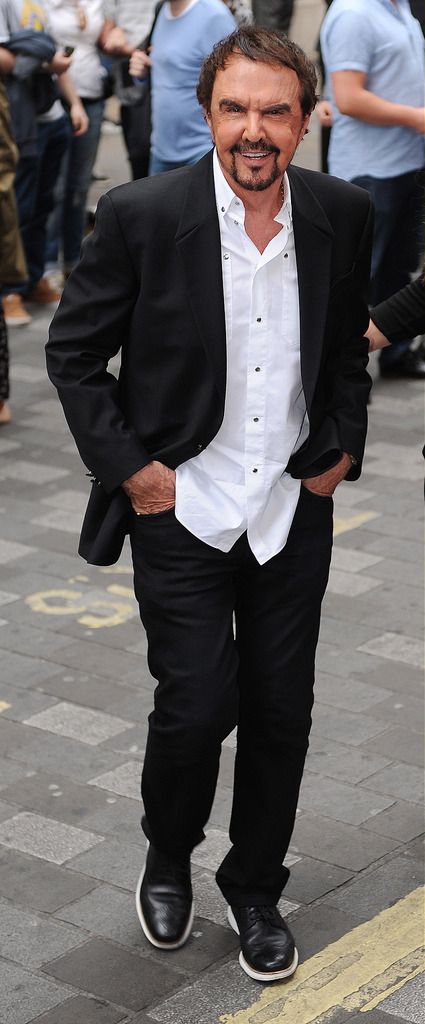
[306,733,391,784]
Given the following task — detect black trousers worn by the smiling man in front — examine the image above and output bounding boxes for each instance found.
[131,487,333,906]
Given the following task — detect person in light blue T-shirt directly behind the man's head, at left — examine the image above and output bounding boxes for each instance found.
[130,0,237,174]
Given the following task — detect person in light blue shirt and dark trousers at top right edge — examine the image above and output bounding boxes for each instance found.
[321,0,425,377]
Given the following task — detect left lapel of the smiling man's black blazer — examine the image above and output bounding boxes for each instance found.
[175,154,226,397]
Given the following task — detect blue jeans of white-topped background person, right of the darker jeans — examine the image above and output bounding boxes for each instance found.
[46,99,104,270]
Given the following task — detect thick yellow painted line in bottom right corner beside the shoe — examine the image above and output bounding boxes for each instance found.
[220,888,424,1024]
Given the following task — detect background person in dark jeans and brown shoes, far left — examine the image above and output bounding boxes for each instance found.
[0,0,88,327]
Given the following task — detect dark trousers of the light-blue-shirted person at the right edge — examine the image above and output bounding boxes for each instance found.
[353,170,425,366]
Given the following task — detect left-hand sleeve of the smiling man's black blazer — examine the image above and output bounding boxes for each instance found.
[46,195,151,493]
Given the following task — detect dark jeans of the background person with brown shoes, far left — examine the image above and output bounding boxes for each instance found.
[2,115,71,295]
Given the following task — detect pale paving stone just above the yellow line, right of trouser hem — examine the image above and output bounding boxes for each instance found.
[291,812,398,871]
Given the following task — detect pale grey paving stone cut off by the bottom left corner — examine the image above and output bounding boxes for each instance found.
[0,963,70,1024]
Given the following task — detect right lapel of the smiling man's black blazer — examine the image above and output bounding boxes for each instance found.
[288,167,334,413]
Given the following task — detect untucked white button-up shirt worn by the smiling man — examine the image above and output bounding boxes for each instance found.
[175,152,309,565]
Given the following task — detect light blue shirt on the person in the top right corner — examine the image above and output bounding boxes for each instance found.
[321,0,425,181]
